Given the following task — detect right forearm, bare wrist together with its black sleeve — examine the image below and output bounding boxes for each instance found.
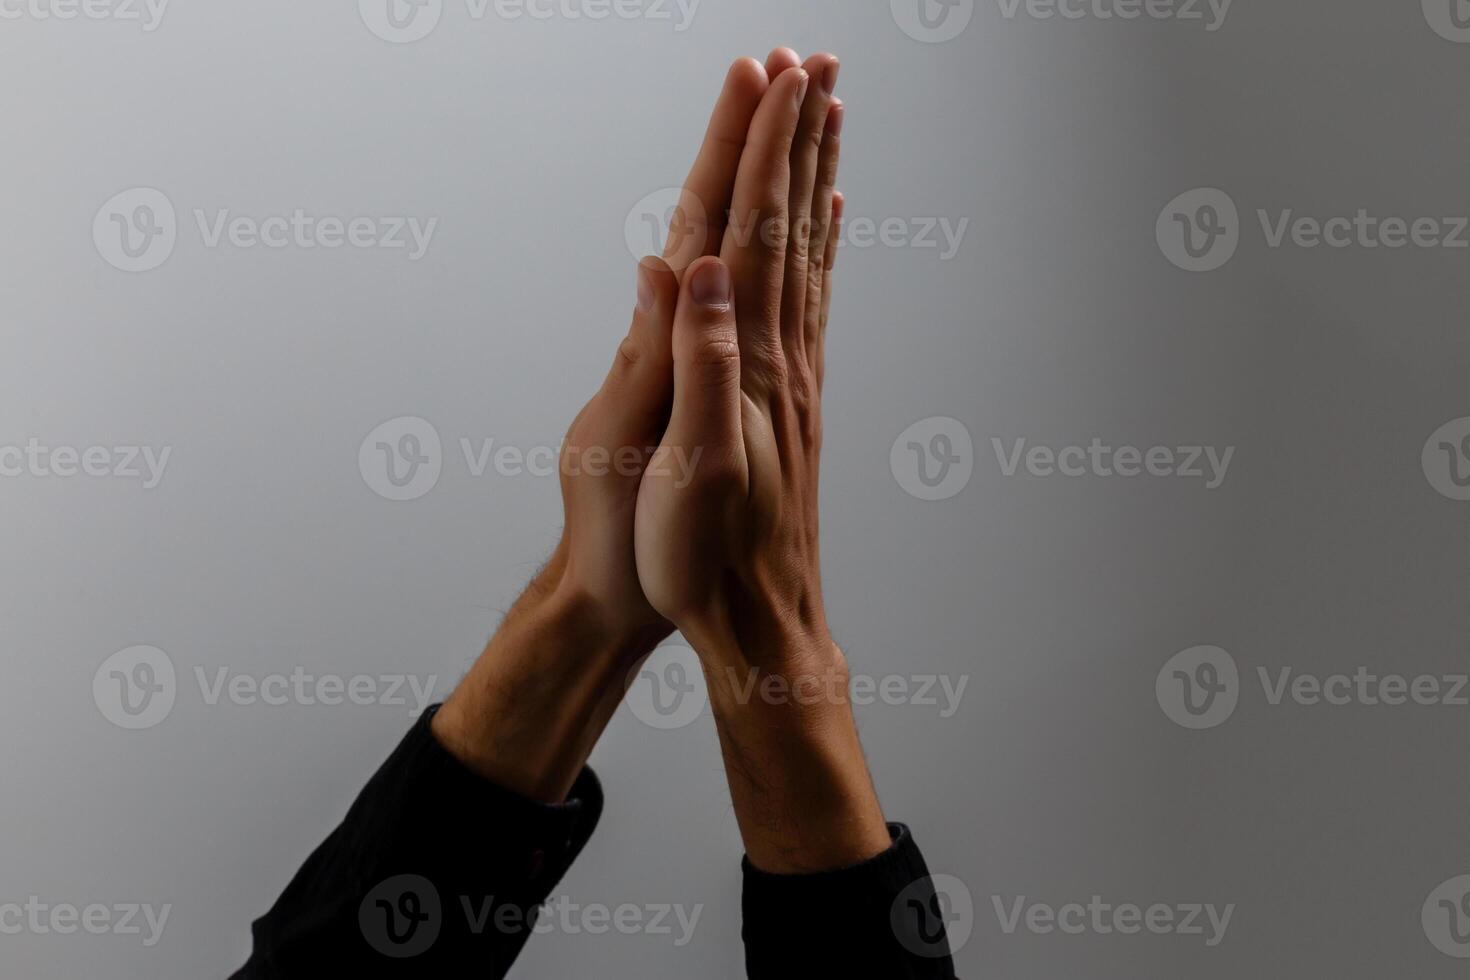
[686,617,954,980]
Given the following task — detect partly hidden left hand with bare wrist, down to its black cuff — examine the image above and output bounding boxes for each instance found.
[434,50,795,801]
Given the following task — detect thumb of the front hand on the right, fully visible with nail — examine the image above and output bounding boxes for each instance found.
[664,257,741,450]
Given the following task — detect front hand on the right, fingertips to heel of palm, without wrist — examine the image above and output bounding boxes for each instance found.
[637,54,844,675]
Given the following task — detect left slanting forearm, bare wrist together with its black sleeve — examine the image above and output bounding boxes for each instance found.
[238,550,660,980]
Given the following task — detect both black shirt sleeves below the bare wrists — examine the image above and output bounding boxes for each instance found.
[234,708,954,980]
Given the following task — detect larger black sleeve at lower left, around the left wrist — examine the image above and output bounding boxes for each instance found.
[234,708,603,980]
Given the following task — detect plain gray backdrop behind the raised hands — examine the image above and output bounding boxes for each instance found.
[0,0,1470,980]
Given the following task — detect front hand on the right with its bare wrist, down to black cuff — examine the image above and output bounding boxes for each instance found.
[634,54,891,873]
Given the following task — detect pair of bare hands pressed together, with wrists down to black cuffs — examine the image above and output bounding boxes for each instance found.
[434,48,889,873]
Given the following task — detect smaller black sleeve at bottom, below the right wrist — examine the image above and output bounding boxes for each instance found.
[741,823,954,980]
